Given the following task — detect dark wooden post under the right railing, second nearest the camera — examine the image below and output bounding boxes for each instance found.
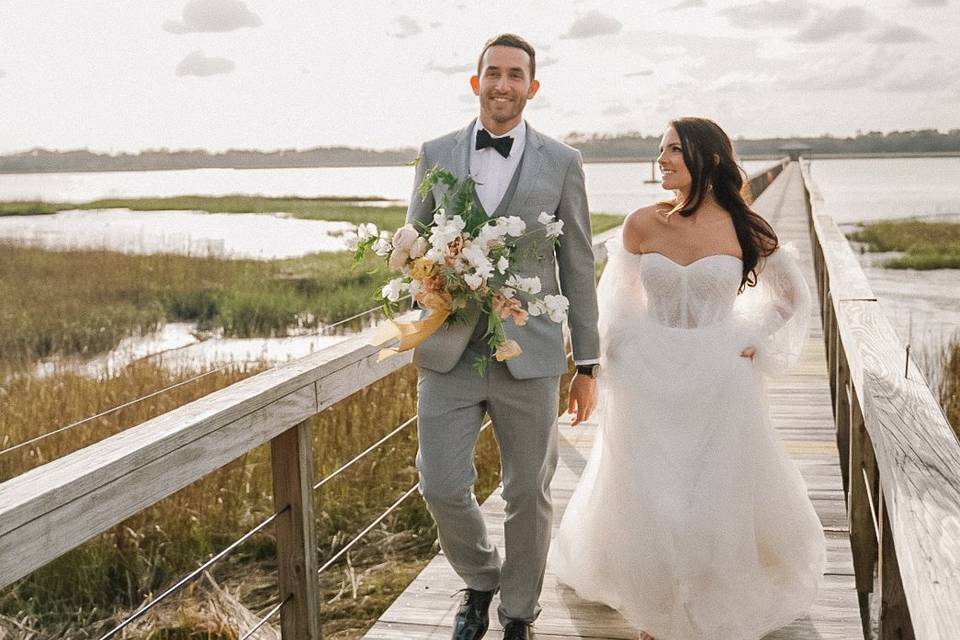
[847,392,879,638]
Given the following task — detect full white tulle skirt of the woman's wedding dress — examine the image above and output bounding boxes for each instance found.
[550,320,825,640]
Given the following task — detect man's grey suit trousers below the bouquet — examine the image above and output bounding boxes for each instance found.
[417,339,560,623]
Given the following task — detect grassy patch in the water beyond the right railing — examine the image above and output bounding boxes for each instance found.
[849,220,960,269]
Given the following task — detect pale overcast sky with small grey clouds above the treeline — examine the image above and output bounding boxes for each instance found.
[0,0,960,152]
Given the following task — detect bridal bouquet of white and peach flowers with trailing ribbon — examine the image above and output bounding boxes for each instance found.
[347,167,569,374]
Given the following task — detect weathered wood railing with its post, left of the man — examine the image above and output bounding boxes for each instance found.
[0,164,782,640]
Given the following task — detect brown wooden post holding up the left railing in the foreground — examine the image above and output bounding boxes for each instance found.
[270,421,320,640]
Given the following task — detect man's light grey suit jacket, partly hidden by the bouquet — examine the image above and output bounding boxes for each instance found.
[407,120,600,379]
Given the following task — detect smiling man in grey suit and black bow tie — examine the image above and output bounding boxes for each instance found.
[407,34,599,640]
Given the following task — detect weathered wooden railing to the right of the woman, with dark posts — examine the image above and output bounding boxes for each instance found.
[804,165,960,640]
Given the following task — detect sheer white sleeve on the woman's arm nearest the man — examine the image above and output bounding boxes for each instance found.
[597,238,647,366]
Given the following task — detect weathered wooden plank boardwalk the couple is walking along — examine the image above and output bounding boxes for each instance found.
[365,163,863,640]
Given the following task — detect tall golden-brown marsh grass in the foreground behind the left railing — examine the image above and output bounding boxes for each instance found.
[0,362,510,637]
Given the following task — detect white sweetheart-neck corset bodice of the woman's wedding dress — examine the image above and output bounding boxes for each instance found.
[635,253,743,329]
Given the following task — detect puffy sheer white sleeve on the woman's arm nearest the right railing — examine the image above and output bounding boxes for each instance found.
[736,243,811,374]
